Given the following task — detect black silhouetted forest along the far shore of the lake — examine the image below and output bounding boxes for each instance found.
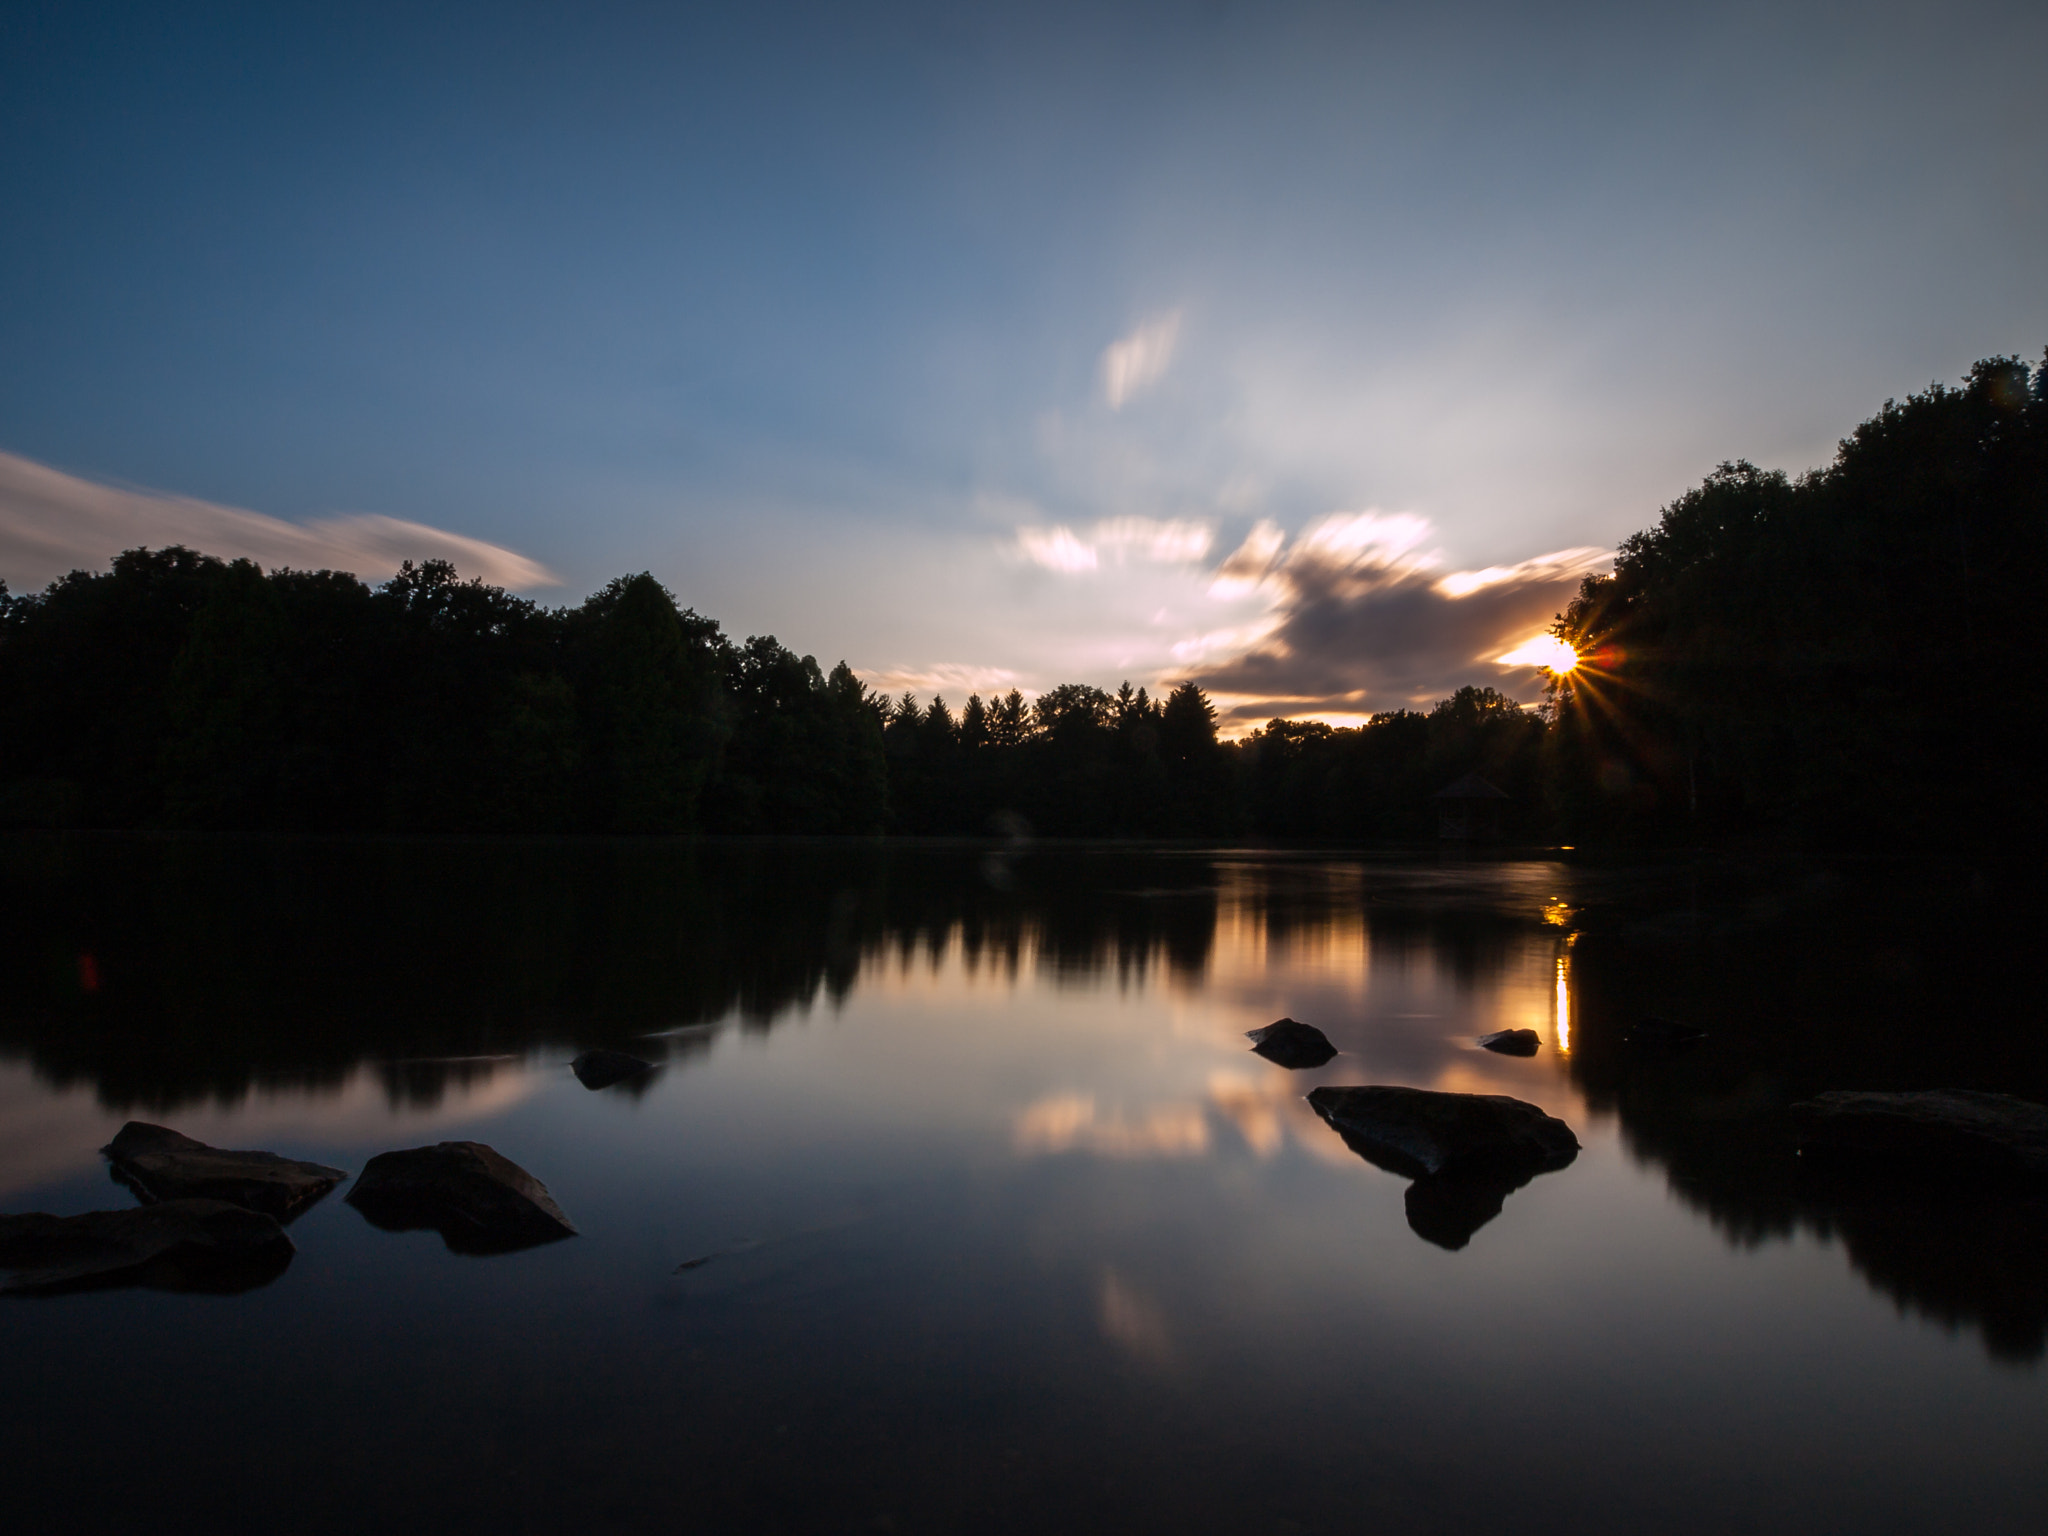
[0,358,2048,844]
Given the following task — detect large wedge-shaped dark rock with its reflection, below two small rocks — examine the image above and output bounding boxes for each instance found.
[1309,1087,1579,1249]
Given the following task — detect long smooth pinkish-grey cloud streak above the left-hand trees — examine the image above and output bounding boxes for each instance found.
[0,453,561,592]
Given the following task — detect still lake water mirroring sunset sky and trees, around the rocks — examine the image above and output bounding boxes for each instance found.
[0,838,2048,1532]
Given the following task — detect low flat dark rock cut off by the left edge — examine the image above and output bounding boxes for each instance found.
[0,1200,293,1294]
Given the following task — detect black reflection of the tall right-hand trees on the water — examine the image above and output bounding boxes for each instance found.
[1571,881,2048,1362]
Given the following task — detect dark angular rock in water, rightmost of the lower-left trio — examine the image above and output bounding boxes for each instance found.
[348,1141,575,1253]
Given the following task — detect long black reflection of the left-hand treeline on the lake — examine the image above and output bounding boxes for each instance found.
[0,838,1214,1110]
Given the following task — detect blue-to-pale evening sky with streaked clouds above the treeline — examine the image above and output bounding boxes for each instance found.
[0,0,2048,731]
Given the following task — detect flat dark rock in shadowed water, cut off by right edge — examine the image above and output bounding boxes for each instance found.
[1792,1087,2048,1182]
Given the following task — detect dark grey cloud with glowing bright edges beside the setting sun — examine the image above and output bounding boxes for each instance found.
[1176,512,1610,729]
